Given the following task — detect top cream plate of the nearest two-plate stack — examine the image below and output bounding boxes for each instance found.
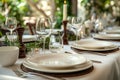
[26,53,86,69]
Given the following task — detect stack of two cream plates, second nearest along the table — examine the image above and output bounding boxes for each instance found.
[72,39,118,51]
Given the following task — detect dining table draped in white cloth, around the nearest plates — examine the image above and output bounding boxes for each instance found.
[0,38,120,80]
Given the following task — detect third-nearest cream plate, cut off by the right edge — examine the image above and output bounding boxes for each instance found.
[93,34,120,40]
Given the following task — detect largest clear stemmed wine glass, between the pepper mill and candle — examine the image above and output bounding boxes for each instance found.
[36,17,52,53]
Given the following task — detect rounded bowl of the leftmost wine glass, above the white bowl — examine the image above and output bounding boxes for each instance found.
[4,17,17,35]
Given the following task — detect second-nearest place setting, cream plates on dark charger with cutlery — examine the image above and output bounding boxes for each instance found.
[71,39,119,57]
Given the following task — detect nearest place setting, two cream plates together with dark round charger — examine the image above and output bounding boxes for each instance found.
[17,45,94,80]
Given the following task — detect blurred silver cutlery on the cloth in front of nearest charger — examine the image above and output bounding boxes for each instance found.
[13,68,66,80]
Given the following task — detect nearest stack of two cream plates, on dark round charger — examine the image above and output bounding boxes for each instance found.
[23,53,92,73]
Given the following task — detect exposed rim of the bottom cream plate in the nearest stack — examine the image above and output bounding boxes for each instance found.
[23,61,93,73]
